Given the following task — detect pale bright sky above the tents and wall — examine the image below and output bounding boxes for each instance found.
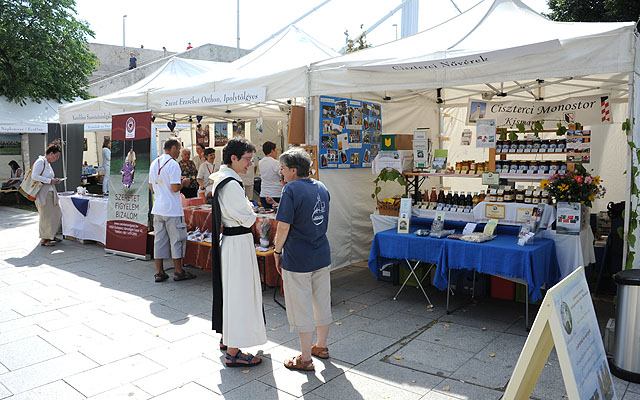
[76,0,549,51]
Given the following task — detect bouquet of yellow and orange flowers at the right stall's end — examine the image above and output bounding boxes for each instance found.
[540,164,607,230]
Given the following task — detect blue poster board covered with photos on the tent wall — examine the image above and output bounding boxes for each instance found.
[319,96,382,168]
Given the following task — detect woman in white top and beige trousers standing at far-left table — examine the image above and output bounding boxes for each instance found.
[31,142,62,246]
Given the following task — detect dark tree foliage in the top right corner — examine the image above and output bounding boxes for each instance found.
[547,0,640,22]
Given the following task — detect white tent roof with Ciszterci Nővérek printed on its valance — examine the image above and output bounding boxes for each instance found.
[311,0,635,95]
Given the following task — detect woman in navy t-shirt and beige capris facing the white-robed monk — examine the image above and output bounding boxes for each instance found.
[274,148,332,371]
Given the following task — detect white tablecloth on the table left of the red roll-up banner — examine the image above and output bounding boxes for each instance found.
[60,195,108,244]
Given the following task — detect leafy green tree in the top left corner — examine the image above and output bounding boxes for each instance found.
[0,0,98,104]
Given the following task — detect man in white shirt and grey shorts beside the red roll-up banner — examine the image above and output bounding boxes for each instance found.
[149,139,196,282]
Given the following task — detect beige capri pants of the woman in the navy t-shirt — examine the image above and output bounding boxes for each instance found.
[282,266,333,333]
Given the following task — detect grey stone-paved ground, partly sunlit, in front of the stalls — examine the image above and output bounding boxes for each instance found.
[0,207,640,400]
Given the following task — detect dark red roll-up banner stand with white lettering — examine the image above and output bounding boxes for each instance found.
[105,111,151,260]
